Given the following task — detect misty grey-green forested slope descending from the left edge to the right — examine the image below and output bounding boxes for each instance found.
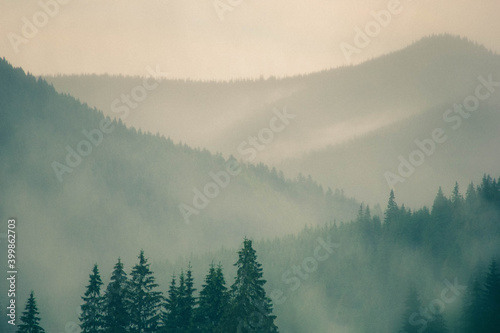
[0,60,359,331]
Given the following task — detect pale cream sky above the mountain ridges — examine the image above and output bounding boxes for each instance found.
[0,0,500,79]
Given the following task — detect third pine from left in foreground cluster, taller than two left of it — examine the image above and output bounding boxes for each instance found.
[127,250,163,333]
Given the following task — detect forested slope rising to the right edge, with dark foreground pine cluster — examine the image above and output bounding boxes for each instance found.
[4,176,500,333]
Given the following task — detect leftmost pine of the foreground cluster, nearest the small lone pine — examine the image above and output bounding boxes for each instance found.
[80,264,104,333]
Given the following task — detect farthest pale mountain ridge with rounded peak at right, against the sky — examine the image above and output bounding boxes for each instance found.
[47,35,498,169]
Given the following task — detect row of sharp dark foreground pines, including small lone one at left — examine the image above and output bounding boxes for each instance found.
[18,239,278,333]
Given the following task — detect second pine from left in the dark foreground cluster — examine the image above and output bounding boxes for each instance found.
[104,259,129,333]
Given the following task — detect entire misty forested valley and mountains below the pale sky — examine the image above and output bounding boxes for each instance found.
[0,34,500,333]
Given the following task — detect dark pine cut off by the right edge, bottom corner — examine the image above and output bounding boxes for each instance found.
[483,260,500,333]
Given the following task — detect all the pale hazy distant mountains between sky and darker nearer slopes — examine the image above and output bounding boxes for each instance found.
[47,35,500,207]
